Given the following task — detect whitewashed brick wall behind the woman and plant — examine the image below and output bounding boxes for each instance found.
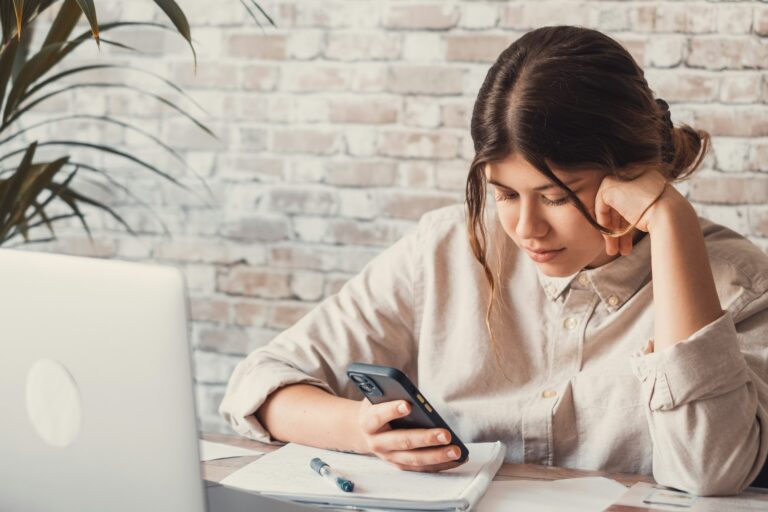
[19,0,768,430]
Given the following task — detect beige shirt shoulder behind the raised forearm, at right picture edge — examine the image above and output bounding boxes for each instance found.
[699,217,768,313]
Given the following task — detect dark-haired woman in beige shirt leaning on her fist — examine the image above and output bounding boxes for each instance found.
[221,26,768,495]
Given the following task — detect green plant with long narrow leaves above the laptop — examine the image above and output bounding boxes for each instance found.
[0,0,274,245]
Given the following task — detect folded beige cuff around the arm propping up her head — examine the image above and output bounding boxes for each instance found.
[630,311,749,411]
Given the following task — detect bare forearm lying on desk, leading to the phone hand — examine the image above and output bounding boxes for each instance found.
[256,384,363,452]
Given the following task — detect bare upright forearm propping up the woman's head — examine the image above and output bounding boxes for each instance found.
[649,187,723,351]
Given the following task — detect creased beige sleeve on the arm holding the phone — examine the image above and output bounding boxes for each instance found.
[219,229,419,443]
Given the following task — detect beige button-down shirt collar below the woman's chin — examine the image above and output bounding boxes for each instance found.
[536,234,651,310]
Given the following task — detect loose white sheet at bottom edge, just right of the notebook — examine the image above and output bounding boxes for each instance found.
[475,477,627,512]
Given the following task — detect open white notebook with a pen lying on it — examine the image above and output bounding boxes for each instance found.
[221,441,506,511]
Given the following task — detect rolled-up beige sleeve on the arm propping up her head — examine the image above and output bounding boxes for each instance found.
[631,293,768,495]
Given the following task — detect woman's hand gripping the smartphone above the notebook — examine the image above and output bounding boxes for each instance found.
[358,398,463,472]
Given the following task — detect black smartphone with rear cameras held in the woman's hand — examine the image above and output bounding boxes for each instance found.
[347,363,469,462]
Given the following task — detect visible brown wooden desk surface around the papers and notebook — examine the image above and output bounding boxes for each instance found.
[201,434,654,512]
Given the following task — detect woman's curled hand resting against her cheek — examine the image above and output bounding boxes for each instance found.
[595,169,674,256]
